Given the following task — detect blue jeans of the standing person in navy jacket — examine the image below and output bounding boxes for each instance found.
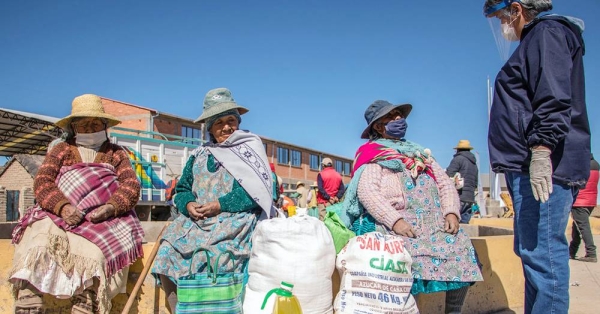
[504,172,574,314]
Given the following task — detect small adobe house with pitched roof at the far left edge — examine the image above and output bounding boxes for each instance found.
[0,154,44,222]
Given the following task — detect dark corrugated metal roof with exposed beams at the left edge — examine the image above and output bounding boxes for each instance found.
[0,108,62,156]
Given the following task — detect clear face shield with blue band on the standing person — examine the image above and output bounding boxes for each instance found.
[484,0,518,61]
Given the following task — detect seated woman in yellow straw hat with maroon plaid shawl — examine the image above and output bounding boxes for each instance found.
[9,94,143,313]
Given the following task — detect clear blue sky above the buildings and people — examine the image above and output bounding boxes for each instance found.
[0,0,600,172]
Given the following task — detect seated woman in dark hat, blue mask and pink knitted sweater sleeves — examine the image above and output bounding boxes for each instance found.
[344,100,483,313]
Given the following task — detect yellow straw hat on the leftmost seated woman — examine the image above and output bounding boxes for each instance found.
[55,94,121,129]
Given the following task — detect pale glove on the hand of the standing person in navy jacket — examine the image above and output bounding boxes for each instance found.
[529,146,552,203]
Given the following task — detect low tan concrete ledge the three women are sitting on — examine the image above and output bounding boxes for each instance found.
[0,222,524,314]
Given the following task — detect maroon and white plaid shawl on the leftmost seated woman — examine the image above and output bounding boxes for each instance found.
[13,163,144,277]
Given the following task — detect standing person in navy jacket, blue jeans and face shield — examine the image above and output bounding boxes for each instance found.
[484,0,590,314]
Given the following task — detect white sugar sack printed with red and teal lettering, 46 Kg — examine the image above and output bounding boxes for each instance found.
[334,232,419,314]
